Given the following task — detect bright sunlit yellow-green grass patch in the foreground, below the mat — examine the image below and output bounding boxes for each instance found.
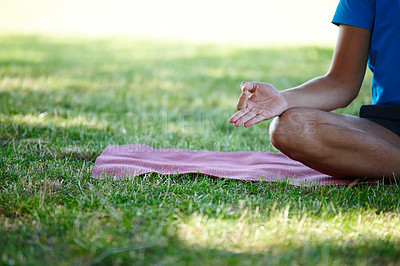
[178,207,400,253]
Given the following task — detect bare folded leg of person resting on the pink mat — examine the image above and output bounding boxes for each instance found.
[270,108,400,179]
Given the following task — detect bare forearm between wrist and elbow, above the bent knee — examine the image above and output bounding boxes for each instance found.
[281,75,361,111]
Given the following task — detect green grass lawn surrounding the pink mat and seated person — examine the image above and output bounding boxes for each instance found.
[0,36,400,265]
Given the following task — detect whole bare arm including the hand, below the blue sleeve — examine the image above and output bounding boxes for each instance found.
[229,25,371,127]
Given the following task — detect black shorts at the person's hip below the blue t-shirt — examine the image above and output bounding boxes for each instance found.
[360,105,400,136]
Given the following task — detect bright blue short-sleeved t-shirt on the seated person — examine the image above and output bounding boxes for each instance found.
[332,0,400,105]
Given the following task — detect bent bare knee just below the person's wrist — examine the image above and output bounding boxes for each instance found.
[269,108,317,157]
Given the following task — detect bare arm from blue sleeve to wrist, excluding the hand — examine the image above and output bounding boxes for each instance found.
[282,25,371,111]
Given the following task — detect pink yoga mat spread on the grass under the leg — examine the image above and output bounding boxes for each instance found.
[93,145,378,185]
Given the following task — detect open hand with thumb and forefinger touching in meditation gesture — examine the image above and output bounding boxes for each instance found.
[229,82,288,127]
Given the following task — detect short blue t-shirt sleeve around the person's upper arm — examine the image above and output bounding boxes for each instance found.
[332,0,374,30]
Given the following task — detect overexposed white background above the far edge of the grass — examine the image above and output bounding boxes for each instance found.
[0,0,338,45]
